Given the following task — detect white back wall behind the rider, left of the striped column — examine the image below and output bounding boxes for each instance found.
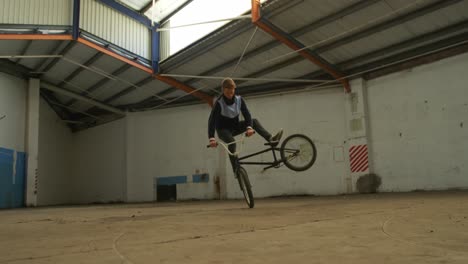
[127,89,346,201]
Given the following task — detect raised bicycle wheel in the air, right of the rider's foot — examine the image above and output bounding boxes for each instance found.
[280,134,317,171]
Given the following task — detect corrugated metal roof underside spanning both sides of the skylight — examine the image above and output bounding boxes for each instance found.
[0,0,468,130]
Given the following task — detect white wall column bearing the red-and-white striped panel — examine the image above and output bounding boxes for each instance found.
[345,79,370,193]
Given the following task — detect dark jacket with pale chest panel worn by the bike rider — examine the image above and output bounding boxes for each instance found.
[208,95,252,138]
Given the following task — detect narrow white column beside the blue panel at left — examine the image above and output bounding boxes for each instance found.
[26,79,40,206]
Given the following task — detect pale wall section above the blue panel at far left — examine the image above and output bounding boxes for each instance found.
[0,73,27,152]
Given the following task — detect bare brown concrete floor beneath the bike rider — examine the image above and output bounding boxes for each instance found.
[0,192,468,264]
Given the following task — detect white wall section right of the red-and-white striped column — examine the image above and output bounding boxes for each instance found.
[367,54,468,191]
